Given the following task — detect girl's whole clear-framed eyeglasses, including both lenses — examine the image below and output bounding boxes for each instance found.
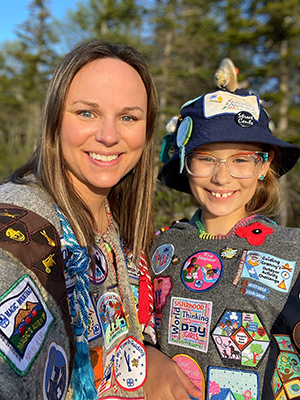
[185,151,269,178]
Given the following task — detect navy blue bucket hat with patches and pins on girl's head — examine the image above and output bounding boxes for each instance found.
[158,89,300,193]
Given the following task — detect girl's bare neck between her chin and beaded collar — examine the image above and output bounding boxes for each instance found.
[201,210,249,235]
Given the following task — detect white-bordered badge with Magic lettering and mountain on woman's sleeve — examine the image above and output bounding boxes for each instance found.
[0,275,54,376]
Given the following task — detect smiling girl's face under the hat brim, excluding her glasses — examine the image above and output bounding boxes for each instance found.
[189,143,272,223]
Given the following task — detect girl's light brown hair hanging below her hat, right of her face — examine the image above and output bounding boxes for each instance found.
[246,148,281,218]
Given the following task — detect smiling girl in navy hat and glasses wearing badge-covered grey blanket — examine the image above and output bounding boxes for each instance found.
[152,90,300,400]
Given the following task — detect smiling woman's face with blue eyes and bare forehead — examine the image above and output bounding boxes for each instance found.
[61,58,147,201]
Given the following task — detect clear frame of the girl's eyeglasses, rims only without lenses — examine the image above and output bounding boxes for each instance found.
[184,151,269,179]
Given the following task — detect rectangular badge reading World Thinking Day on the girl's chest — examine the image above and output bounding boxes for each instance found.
[168,297,212,353]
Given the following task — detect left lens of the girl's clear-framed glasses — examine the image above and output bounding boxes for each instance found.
[185,153,217,177]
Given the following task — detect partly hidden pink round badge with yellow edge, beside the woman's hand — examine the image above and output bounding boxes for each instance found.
[172,354,205,400]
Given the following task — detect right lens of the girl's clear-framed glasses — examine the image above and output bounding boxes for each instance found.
[227,154,263,177]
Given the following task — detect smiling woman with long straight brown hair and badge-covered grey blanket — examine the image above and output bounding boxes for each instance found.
[0,40,158,400]
